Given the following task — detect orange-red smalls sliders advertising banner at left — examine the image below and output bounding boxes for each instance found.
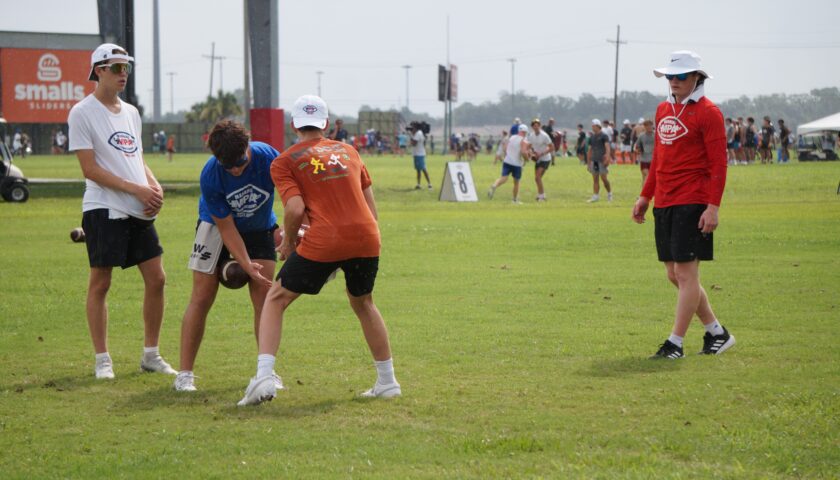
[0,48,96,123]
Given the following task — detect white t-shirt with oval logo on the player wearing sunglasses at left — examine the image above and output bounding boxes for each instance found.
[67,94,153,220]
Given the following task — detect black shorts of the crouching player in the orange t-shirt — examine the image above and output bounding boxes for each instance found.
[276,252,379,297]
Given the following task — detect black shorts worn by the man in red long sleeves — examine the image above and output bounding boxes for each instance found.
[653,205,714,262]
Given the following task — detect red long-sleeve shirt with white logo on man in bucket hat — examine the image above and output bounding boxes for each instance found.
[641,97,726,208]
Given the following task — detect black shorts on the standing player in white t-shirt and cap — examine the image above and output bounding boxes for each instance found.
[82,208,163,268]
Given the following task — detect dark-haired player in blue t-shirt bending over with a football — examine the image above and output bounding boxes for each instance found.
[175,120,283,392]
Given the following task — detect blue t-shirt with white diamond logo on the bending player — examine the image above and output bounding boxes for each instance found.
[198,142,280,232]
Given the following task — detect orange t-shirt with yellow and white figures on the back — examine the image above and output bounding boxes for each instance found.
[271,138,381,262]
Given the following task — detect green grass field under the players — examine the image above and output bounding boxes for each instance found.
[0,155,840,479]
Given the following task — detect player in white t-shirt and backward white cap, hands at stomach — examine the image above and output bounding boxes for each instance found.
[67,43,177,379]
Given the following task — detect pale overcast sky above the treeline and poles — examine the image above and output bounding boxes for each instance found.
[0,0,840,116]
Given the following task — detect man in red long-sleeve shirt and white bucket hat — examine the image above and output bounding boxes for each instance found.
[633,51,735,359]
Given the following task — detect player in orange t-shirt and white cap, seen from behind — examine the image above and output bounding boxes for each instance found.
[239,95,402,406]
